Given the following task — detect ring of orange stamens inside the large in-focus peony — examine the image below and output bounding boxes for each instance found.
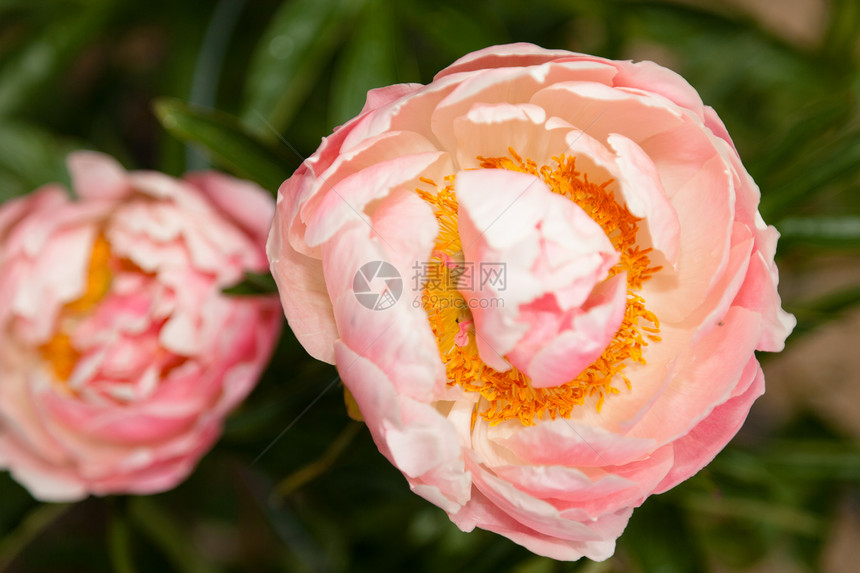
[416,149,661,426]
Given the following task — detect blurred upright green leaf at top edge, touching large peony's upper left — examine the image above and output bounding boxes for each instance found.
[329,0,397,125]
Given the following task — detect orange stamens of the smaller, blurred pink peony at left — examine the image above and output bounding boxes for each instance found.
[40,234,113,382]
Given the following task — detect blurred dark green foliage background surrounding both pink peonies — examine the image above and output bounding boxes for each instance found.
[0,0,860,573]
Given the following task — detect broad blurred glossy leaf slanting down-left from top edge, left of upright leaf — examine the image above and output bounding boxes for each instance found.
[240,0,363,138]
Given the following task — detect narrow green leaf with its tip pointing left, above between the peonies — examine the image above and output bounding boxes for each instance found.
[155,99,299,195]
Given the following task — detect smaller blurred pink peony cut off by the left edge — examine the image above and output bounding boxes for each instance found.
[0,152,282,501]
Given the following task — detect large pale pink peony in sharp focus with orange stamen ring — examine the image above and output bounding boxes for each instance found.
[268,44,794,560]
